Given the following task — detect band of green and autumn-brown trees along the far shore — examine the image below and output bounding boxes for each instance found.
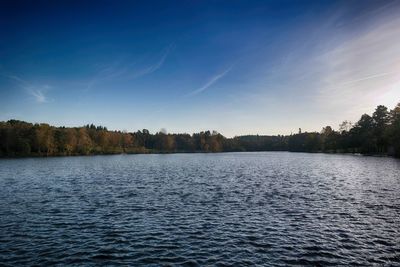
[0,103,400,157]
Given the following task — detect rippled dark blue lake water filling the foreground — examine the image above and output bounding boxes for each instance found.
[0,152,400,266]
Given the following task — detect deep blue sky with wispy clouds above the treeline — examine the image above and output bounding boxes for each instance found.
[0,0,400,137]
